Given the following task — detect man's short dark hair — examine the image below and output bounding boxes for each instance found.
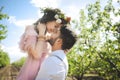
[60,26,77,50]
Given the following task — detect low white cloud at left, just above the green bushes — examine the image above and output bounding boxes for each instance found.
[2,45,27,63]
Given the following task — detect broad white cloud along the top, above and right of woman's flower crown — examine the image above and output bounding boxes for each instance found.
[30,0,85,19]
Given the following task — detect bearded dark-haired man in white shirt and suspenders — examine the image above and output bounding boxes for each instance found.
[36,26,76,80]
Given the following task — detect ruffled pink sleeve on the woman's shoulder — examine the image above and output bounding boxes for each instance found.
[19,26,37,52]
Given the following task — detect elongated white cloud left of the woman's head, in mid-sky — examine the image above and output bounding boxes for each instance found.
[8,16,36,27]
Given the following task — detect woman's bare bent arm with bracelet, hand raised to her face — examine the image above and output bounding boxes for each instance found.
[28,23,47,59]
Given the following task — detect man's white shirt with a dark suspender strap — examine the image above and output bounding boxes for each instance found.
[36,50,68,80]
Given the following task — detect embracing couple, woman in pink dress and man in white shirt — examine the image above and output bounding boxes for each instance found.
[17,8,77,80]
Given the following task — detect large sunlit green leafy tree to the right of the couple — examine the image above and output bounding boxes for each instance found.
[68,0,120,80]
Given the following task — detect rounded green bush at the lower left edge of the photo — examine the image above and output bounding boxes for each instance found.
[0,49,10,68]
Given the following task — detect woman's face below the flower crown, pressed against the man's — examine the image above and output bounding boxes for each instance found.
[46,21,60,33]
